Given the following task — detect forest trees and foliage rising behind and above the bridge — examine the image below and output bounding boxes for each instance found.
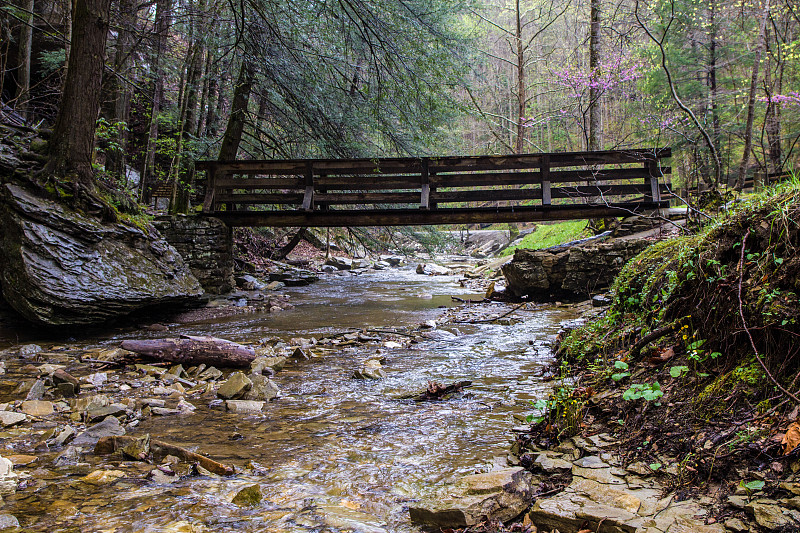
[0,0,800,204]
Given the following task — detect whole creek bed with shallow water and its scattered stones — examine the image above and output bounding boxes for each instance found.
[0,262,574,532]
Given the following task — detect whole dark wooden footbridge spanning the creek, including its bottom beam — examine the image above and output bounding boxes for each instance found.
[195,148,671,227]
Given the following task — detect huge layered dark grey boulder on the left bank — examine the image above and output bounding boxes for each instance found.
[0,183,203,325]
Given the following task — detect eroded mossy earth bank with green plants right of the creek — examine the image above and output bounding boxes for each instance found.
[510,185,800,531]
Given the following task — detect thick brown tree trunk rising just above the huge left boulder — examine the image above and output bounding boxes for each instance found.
[48,0,111,186]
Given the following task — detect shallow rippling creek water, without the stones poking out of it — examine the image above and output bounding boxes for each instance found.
[0,269,575,533]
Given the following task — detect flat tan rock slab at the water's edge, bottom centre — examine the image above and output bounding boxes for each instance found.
[409,467,533,528]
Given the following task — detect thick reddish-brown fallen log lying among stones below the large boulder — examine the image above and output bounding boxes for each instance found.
[120,335,256,367]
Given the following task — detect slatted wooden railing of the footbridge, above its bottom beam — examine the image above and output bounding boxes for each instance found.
[195,148,671,227]
